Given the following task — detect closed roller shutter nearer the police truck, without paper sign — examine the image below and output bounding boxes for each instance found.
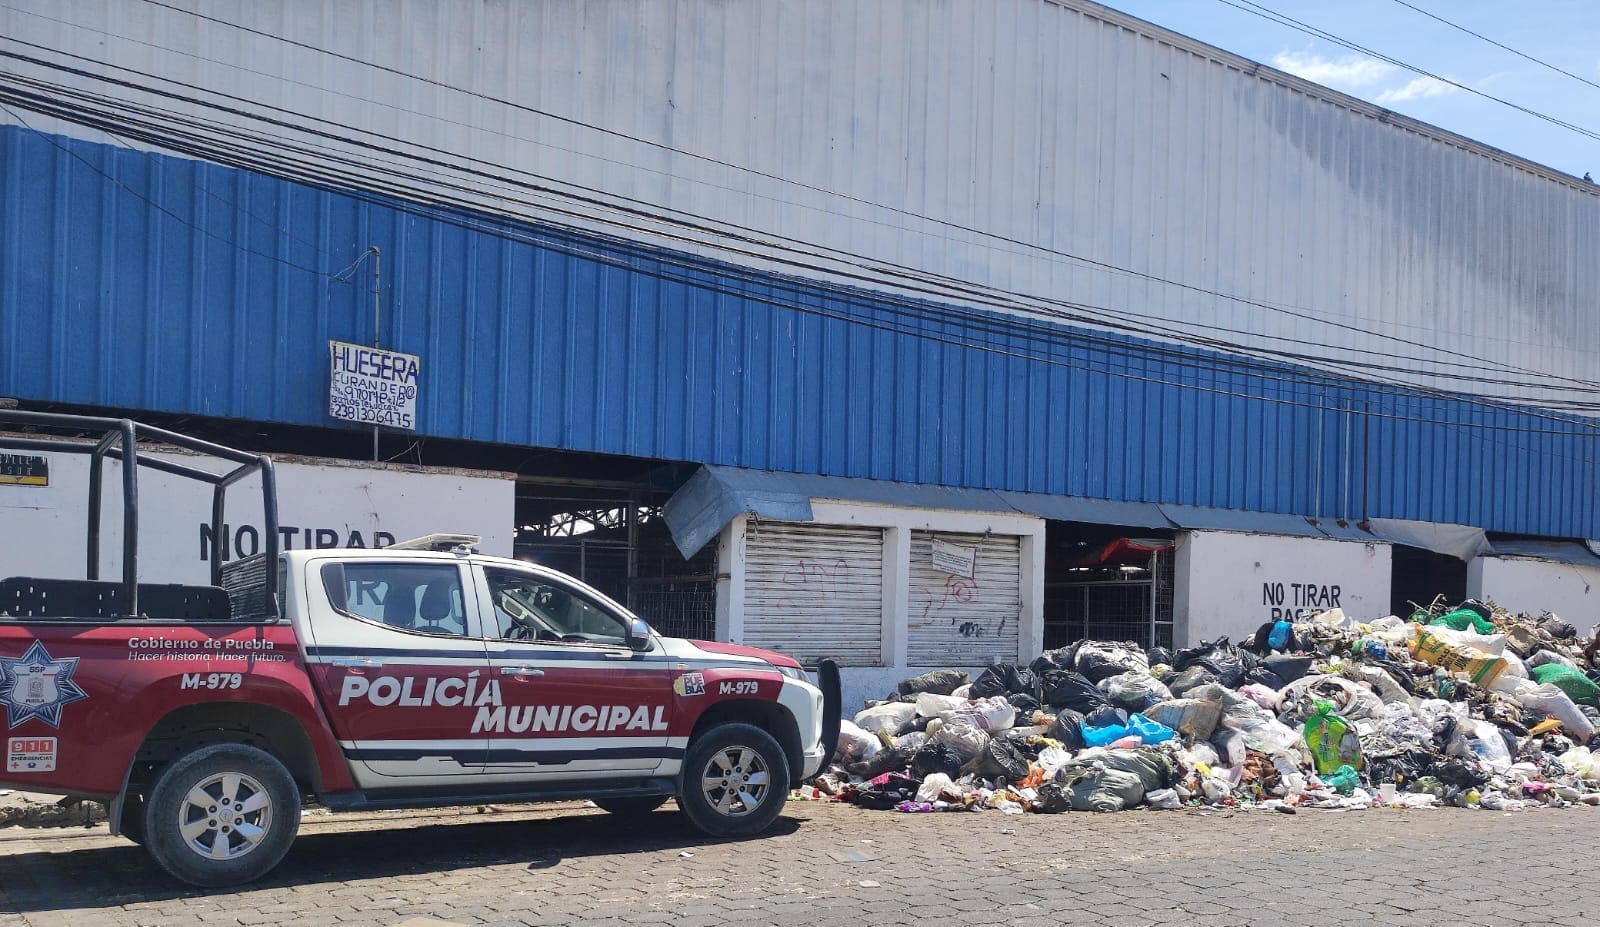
[744,519,883,666]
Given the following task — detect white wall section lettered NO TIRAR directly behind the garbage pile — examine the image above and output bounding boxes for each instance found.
[1173,532,1390,647]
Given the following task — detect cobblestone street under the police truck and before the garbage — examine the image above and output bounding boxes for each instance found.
[0,802,1600,927]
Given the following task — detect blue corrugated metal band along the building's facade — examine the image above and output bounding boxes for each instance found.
[0,126,1600,536]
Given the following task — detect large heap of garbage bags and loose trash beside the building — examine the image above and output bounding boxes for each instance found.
[805,600,1600,813]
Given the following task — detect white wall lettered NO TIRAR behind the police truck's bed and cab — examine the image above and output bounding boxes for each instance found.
[0,453,515,583]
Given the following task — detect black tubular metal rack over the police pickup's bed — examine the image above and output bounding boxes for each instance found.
[0,408,278,620]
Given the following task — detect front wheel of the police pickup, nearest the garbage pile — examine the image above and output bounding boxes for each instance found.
[678,724,789,837]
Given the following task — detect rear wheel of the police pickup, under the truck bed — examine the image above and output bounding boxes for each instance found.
[144,743,301,889]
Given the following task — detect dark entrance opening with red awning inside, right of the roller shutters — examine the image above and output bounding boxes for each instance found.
[1045,522,1174,650]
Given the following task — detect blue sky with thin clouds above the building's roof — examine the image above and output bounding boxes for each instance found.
[1101,0,1600,181]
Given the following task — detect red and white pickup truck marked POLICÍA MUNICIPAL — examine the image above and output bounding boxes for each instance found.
[0,411,840,887]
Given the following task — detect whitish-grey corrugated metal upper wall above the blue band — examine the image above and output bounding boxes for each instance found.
[0,0,1600,406]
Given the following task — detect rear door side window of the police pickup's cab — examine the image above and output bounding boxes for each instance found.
[323,562,467,634]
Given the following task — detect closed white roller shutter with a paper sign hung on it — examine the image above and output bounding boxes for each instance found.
[906,532,1022,666]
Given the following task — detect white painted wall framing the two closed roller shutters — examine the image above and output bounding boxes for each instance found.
[717,500,1045,716]
